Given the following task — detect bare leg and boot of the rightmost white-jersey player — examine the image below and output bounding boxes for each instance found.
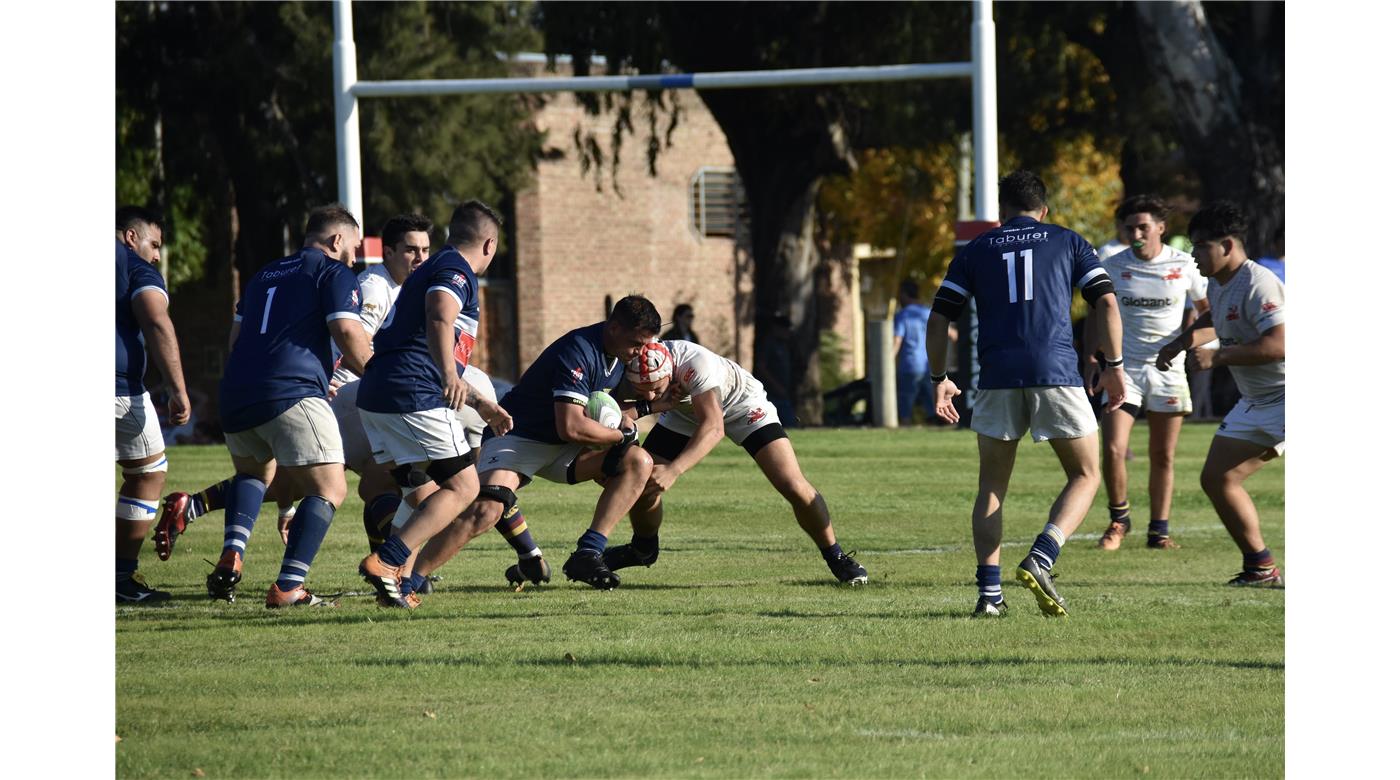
[1201,436,1282,585]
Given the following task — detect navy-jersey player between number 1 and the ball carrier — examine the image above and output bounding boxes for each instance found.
[357,200,511,609]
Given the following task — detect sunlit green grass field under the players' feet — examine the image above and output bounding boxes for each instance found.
[116,424,1284,777]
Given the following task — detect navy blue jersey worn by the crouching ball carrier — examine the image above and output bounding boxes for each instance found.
[501,322,623,444]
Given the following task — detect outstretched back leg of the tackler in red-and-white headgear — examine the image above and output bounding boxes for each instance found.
[743,424,869,585]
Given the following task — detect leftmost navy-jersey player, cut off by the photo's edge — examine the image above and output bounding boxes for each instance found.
[116,206,189,604]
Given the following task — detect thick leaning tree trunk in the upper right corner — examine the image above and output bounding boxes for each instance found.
[1133,0,1284,256]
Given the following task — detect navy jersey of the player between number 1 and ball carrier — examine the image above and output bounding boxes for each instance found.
[356,246,482,415]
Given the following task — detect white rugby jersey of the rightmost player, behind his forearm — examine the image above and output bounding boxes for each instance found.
[1207,260,1284,403]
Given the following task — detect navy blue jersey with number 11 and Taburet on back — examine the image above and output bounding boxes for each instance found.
[944,217,1107,389]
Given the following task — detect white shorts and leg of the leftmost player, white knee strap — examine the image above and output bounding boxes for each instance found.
[115,394,171,604]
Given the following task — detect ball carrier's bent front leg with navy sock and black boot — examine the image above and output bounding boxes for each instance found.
[564,444,652,590]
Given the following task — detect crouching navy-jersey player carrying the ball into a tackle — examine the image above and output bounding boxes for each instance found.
[409,295,661,590]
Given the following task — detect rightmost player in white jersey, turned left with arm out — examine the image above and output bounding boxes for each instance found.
[1156,202,1284,587]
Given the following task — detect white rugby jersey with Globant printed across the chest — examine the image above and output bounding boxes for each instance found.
[1103,245,1205,371]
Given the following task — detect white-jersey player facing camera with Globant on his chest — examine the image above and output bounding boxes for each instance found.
[1084,195,1210,550]
